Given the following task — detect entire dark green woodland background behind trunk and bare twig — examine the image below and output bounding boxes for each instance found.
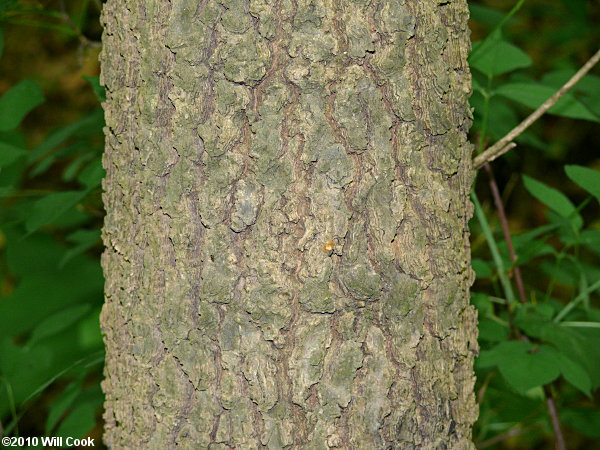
[0,0,600,449]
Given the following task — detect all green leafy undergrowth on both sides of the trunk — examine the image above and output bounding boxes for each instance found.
[0,0,600,448]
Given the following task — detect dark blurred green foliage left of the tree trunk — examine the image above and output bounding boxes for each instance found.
[0,0,104,438]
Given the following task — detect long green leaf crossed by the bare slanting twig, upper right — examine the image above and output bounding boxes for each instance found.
[495,83,600,122]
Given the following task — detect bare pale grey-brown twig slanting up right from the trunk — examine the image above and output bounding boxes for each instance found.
[473,50,600,169]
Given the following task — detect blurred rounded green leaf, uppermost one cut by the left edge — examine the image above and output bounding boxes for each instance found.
[0,80,44,131]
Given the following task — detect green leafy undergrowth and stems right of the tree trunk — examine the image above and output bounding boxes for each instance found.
[469,1,600,448]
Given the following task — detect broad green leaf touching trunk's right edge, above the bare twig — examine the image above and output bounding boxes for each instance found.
[469,32,531,78]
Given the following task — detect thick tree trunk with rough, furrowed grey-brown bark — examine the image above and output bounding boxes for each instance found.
[102,0,477,450]
